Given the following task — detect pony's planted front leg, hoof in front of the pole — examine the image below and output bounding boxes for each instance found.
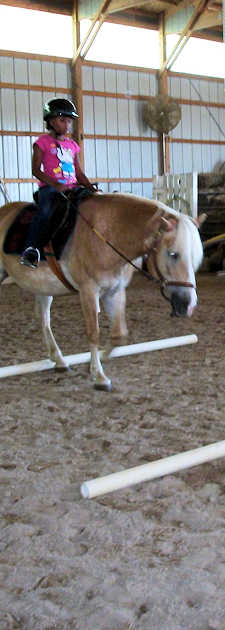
[80,286,112,391]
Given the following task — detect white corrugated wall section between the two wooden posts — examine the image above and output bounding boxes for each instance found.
[83,64,158,196]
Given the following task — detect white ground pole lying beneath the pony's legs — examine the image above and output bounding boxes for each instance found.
[0,335,198,378]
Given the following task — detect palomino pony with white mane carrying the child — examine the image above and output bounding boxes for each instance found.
[0,193,203,390]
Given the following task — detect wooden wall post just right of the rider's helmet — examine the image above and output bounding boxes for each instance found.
[71,0,85,169]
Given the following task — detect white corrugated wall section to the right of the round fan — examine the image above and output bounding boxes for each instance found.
[168,73,225,173]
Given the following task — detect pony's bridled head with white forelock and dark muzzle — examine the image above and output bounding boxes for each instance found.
[146,204,203,317]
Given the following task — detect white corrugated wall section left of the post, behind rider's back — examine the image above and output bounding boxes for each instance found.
[0,53,71,203]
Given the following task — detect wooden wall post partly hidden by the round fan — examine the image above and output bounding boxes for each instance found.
[158,14,170,175]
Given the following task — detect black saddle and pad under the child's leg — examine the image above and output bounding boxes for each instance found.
[3,186,93,260]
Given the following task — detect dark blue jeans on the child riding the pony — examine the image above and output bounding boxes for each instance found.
[25,186,57,249]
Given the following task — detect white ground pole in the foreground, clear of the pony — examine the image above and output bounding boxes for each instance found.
[80,440,225,499]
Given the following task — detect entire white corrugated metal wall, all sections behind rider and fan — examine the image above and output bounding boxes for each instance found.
[0,52,225,204]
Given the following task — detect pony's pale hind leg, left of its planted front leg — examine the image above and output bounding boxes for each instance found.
[35,295,68,370]
